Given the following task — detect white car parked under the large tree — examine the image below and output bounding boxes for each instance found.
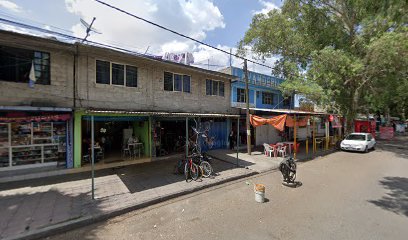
[340,133,376,152]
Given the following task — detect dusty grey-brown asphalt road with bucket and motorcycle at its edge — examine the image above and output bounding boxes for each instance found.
[45,142,408,240]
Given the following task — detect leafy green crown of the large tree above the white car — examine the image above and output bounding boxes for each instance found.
[239,0,408,127]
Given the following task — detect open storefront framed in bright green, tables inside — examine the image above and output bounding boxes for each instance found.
[74,111,150,167]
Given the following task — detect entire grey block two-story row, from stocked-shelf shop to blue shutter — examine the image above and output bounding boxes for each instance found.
[0,31,238,171]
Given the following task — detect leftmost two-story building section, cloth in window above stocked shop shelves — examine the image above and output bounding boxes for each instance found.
[0,31,75,171]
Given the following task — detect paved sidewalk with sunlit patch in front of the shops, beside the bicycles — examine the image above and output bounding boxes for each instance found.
[0,159,257,239]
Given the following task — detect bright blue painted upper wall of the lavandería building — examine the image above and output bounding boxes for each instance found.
[230,67,293,109]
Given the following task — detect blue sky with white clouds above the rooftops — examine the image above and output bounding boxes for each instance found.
[0,0,282,74]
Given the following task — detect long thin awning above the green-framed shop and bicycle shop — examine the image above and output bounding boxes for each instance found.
[85,110,240,118]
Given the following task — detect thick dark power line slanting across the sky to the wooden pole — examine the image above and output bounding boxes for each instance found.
[94,0,273,69]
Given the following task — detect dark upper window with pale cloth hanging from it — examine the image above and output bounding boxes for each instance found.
[0,46,51,85]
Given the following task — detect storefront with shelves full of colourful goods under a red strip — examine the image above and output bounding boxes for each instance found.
[0,108,73,170]
